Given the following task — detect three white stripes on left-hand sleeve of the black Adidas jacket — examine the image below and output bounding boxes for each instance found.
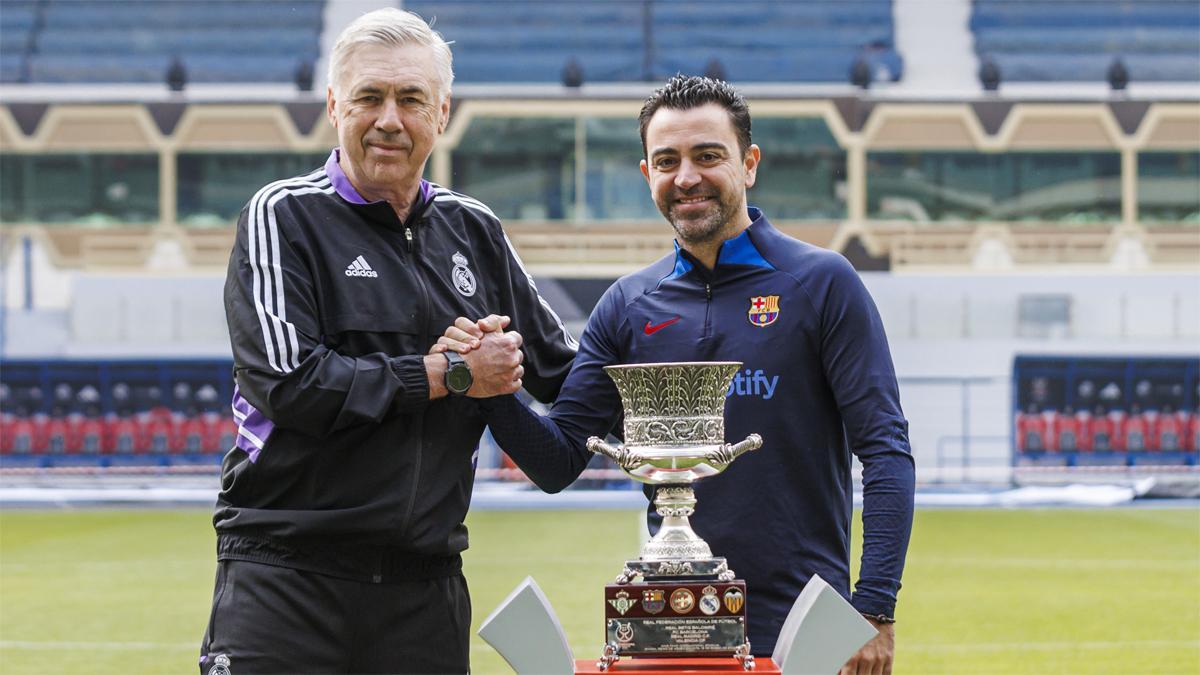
[247,171,334,372]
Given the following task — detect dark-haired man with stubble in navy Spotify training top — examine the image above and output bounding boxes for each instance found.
[436,76,914,674]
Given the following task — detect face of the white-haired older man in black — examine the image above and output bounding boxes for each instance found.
[326,44,450,202]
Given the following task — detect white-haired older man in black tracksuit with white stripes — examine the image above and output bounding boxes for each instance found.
[200,8,576,675]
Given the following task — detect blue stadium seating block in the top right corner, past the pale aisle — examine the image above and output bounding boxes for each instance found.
[971,0,1200,83]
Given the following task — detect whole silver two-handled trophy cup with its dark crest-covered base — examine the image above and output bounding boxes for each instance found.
[587,362,762,670]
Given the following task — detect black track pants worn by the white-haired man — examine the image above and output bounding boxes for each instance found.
[200,561,470,675]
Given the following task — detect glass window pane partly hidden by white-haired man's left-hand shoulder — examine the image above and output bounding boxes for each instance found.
[175,153,329,227]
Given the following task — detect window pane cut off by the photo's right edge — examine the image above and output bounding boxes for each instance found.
[1138,153,1200,225]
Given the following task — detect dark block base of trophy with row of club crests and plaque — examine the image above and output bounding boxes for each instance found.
[605,579,750,659]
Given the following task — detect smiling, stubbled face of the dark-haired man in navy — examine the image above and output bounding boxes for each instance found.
[642,103,760,251]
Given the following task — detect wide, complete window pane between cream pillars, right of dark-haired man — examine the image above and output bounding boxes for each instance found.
[866,151,1121,223]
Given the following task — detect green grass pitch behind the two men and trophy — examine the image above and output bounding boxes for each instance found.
[0,508,1200,675]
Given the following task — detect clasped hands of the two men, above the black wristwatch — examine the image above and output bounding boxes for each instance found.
[430,315,524,399]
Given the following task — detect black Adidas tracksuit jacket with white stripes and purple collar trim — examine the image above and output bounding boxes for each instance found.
[214,150,577,581]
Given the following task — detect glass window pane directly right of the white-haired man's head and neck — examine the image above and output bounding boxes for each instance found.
[450,118,575,220]
